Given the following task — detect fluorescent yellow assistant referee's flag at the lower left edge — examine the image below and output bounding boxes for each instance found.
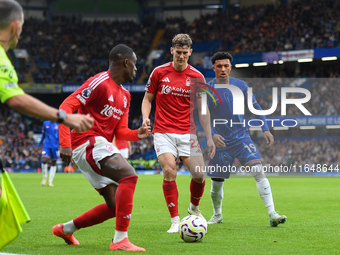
[0,158,30,250]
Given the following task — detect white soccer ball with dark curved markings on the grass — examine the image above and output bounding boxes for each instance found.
[179,215,208,243]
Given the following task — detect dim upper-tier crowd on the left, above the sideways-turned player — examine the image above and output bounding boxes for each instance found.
[19,16,155,84]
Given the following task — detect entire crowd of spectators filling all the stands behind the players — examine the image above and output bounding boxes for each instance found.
[0,0,340,170]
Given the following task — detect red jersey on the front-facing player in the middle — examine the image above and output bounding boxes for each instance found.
[145,62,205,134]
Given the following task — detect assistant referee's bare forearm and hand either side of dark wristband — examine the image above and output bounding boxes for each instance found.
[6,94,93,132]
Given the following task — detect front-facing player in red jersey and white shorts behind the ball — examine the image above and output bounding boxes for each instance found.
[142,34,215,233]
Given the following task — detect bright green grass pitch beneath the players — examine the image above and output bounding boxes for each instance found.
[1,174,340,255]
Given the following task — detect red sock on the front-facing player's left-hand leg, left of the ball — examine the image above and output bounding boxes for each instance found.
[163,180,179,218]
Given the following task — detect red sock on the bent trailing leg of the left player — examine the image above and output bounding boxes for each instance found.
[73,203,116,229]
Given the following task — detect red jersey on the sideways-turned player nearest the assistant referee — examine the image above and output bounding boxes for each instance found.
[72,71,131,148]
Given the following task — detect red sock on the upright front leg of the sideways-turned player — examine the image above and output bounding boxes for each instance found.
[116,175,138,232]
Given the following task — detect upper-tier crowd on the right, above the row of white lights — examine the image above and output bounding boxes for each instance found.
[178,0,340,54]
